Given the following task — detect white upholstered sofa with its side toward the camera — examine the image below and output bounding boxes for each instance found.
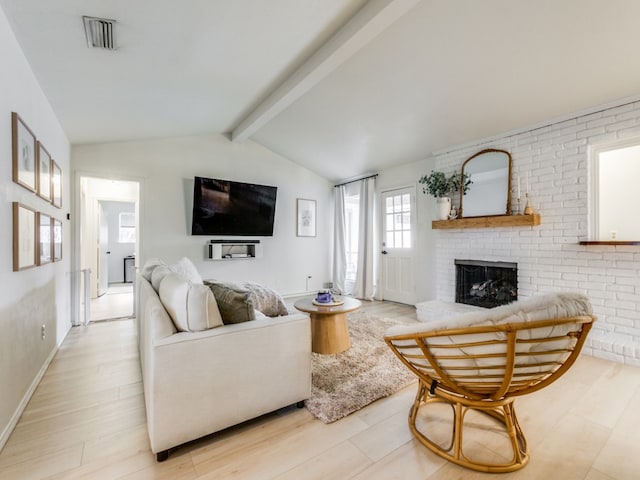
[136,258,311,461]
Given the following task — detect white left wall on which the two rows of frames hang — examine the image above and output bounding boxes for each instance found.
[0,5,71,447]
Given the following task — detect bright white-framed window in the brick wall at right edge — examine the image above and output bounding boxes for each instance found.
[589,138,640,242]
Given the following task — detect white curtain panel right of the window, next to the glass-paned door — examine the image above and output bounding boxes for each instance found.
[353,177,378,300]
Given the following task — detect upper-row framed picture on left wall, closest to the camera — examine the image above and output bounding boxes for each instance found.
[11,112,37,192]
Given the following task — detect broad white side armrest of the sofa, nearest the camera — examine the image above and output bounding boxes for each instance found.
[145,314,311,452]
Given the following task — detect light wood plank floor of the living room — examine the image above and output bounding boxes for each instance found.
[0,302,640,480]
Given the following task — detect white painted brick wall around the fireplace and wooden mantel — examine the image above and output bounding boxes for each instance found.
[436,102,640,366]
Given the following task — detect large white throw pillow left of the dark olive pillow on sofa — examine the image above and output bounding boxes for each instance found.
[159,273,222,332]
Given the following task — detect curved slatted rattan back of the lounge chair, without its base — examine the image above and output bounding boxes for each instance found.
[385,316,593,400]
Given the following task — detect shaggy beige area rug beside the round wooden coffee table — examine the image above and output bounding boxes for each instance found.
[305,312,416,423]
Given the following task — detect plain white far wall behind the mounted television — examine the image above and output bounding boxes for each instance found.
[72,134,333,295]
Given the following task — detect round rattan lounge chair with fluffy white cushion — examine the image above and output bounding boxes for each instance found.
[385,294,595,472]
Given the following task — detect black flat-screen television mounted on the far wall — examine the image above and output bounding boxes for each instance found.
[191,177,277,237]
